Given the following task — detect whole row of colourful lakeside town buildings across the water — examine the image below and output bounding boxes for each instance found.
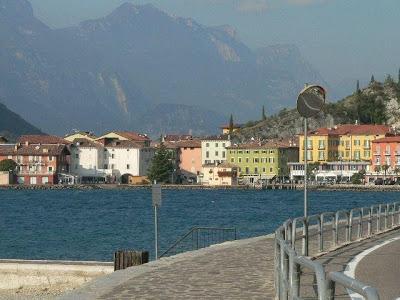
[0,124,400,187]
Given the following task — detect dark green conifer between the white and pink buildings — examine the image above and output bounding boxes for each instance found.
[148,143,174,183]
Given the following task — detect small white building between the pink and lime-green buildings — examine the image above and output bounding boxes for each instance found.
[201,136,231,165]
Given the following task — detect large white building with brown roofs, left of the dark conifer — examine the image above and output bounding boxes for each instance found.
[71,138,154,183]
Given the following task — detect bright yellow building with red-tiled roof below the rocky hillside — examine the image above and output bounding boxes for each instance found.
[299,124,390,163]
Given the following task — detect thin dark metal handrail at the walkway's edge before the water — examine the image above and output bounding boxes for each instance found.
[160,227,237,258]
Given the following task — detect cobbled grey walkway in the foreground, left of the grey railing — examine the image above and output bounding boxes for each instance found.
[61,235,274,299]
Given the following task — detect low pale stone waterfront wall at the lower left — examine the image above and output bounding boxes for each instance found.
[0,260,114,290]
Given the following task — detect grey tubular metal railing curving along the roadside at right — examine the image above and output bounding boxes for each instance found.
[275,202,400,300]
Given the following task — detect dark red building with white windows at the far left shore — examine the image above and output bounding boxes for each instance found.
[0,135,70,184]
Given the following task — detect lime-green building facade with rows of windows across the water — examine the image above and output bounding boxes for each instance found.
[227,142,299,184]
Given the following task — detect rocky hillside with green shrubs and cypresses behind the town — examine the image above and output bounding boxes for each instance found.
[235,70,400,141]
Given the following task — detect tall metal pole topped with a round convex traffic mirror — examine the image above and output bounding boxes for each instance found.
[297,85,326,255]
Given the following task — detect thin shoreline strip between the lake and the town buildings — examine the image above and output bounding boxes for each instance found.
[0,184,400,192]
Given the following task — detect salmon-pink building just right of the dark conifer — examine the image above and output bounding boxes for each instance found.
[175,140,202,182]
